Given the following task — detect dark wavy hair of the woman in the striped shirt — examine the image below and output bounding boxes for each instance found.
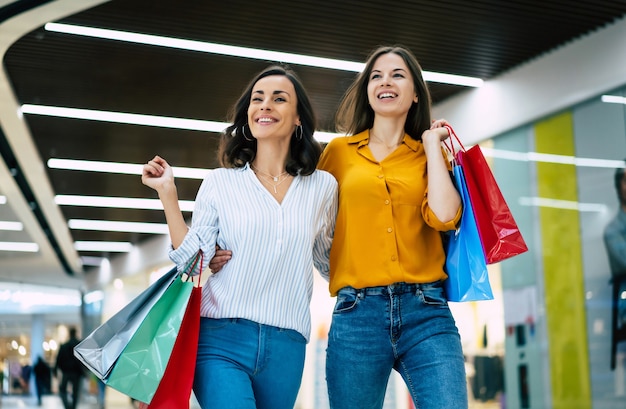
[218,65,322,176]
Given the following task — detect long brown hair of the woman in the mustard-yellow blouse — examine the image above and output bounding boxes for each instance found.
[335,45,431,141]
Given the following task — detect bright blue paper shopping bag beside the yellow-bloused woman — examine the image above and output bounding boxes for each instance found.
[443,164,493,302]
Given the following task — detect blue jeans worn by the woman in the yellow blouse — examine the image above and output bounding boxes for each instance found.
[326,283,468,409]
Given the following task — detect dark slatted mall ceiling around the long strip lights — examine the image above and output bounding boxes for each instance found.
[0,0,626,294]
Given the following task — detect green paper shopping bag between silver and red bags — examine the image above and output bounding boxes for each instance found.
[105,275,194,403]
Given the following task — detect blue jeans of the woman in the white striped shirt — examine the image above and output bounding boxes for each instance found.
[193,318,306,409]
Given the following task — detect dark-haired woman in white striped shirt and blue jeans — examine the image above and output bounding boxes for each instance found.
[142,66,337,409]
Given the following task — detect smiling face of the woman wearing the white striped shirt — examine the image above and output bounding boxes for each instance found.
[248,75,300,140]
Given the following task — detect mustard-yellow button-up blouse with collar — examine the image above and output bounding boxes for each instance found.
[318,131,462,296]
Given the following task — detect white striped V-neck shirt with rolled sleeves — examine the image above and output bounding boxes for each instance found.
[169,165,337,341]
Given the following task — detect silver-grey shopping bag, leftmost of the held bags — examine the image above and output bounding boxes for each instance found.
[74,268,178,380]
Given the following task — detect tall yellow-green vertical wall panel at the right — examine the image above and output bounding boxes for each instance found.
[535,112,591,409]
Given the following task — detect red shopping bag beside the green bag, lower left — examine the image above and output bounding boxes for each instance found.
[139,256,202,409]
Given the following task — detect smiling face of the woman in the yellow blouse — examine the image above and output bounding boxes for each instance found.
[367,53,417,116]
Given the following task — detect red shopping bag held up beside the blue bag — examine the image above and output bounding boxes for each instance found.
[446,126,528,264]
